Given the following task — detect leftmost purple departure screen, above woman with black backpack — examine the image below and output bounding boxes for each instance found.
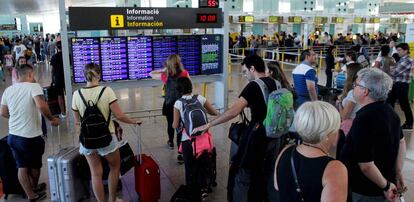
[72,38,100,83]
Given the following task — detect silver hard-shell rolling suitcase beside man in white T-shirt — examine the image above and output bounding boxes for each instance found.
[47,127,88,202]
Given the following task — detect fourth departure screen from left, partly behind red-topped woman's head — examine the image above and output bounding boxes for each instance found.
[152,36,177,70]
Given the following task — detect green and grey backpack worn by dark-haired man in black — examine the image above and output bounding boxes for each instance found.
[255,79,295,138]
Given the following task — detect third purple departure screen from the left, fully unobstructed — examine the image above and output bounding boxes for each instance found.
[128,36,152,80]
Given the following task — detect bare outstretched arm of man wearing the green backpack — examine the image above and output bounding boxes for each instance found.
[193,97,248,133]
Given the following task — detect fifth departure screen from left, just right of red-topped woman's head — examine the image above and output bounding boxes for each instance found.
[177,36,201,75]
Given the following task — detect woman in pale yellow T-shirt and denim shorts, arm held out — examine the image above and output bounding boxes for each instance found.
[72,63,142,202]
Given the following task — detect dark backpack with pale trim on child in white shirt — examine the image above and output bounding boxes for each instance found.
[179,95,208,137]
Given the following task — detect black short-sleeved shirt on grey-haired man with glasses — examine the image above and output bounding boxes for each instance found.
[340,102,404,196]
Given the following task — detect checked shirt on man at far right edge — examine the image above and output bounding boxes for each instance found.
[392,55,414,83]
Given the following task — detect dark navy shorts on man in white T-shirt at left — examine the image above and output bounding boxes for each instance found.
[7,135,45,168]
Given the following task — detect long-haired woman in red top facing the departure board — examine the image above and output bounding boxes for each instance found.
[150,54,190,163]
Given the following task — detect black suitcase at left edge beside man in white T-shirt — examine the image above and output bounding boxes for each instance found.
[0,136,25,200]
